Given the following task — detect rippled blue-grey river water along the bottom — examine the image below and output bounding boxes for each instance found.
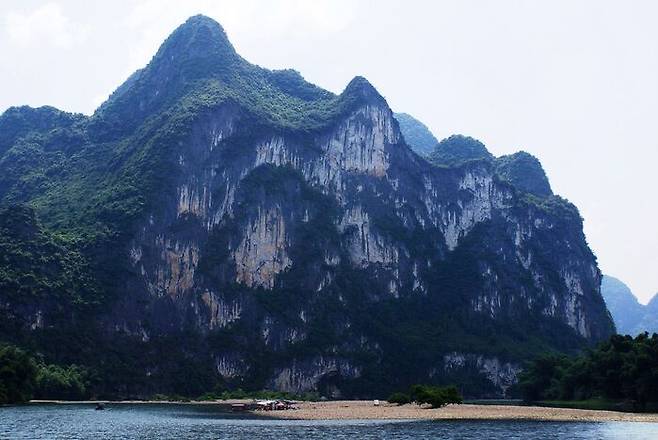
[0,404,658,440]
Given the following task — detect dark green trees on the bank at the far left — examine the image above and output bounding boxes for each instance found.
[0,345,89,404]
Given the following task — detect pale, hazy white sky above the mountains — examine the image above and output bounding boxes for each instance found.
[0,0,658,302]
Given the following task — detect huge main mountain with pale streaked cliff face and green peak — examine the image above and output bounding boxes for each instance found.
[0,16,614,397]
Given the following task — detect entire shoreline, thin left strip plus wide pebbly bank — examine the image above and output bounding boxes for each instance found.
[23,399,658,423]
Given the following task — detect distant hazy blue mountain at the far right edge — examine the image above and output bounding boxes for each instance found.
[601,275,658,336]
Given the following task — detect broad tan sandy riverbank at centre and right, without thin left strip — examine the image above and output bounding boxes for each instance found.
[251,401,658,423]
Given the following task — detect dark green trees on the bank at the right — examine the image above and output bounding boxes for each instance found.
[519,333,658,410]
